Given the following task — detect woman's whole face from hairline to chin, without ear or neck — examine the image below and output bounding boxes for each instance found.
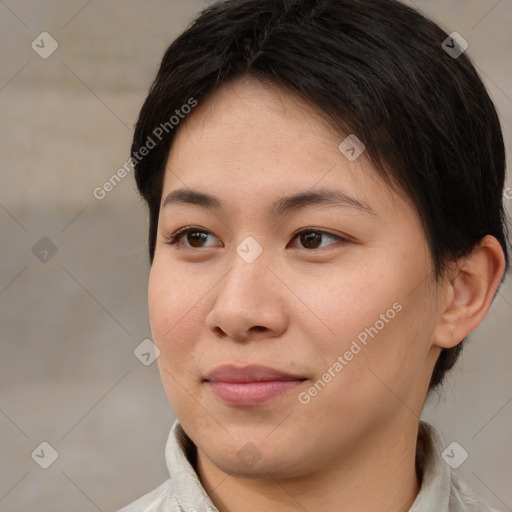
[149,80,441,477]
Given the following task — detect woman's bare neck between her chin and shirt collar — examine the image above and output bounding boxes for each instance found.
[197,418,420,512]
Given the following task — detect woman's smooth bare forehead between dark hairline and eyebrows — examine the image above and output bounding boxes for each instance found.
[162,79,408,217]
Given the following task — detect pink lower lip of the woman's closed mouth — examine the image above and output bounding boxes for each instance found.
[206,380,304,406]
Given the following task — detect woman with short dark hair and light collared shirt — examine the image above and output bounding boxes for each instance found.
[122,0,508,512]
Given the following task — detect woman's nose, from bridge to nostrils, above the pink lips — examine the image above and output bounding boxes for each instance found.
[206,246,290,341]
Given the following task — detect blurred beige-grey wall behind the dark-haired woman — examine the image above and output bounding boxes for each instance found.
[0,0,512,512]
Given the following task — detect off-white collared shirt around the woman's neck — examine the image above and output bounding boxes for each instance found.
[118,420,498,512]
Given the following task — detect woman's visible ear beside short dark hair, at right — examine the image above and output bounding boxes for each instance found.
[433,235,505,348]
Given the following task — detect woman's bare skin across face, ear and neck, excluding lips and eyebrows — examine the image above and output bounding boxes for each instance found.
[149,79,504,512]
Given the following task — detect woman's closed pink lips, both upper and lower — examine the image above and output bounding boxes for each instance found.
[205,365,306,406]
